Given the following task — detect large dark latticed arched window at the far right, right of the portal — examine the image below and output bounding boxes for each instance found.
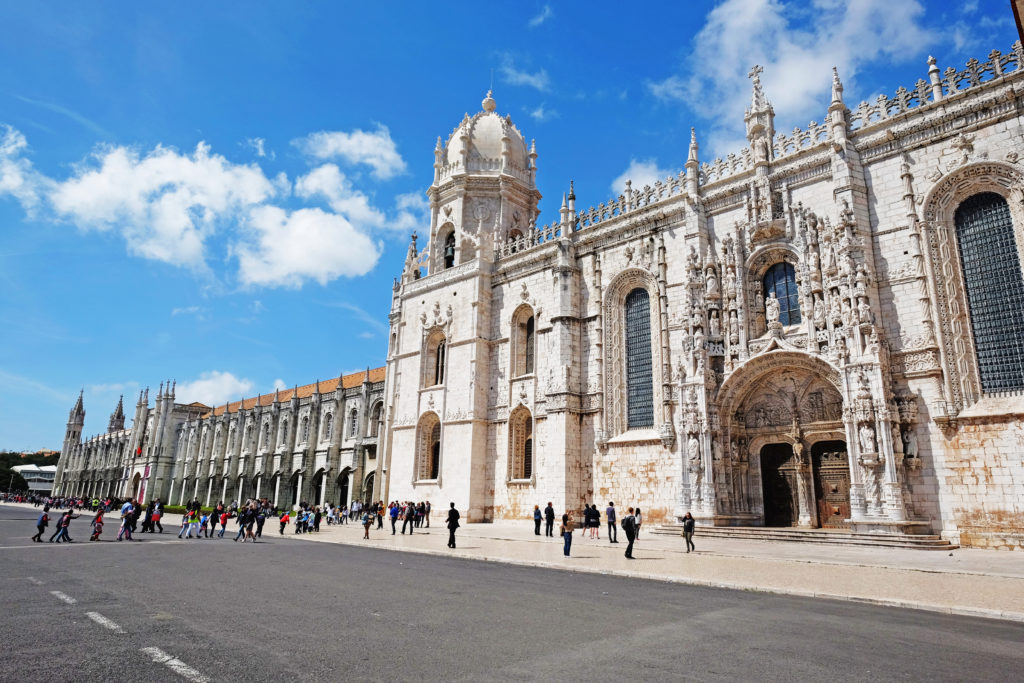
[953,193,1024,393]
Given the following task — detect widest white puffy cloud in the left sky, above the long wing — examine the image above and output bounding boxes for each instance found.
[50,142,275,269]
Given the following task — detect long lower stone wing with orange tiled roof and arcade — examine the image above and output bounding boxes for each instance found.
[54,368,384,508]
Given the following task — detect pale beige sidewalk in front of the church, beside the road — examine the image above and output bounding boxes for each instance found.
[14,506,1024,622]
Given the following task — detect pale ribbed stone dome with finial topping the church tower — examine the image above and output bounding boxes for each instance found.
[443,90,530,179]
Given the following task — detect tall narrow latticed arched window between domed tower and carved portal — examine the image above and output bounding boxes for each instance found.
[625,287,654,429]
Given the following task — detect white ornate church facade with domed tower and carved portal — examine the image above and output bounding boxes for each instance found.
[381,43,1024,547]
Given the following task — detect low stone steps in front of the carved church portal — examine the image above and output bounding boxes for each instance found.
[652,524,959,550]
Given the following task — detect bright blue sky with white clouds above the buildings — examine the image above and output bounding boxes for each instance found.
[0,0,1016,450]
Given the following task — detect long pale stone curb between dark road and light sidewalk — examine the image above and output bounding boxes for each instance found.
[285,533,1024,624]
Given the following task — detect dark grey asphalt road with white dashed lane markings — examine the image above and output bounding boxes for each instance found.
[0,505,1024,682]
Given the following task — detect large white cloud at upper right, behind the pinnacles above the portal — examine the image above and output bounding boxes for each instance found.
[647,0,940,155]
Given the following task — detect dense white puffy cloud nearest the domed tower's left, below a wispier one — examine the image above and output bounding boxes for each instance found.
[234,206,380,288]
